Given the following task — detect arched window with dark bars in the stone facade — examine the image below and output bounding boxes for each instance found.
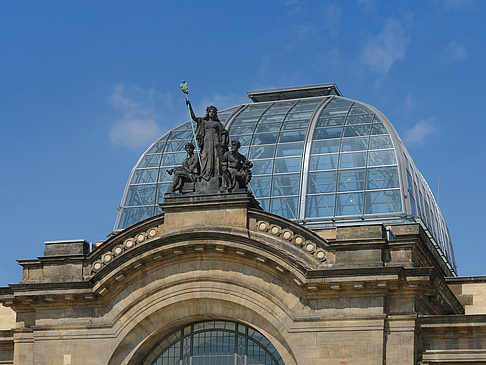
[141,321,284,365]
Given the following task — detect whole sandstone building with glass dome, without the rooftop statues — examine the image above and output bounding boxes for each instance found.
[0,84,486,365]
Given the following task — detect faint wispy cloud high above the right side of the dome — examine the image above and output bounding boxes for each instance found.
[361,19,410,74]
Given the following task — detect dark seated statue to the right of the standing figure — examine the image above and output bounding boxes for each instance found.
[221,141,253,193]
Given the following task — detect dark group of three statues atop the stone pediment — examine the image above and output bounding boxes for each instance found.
[167,100,253,194]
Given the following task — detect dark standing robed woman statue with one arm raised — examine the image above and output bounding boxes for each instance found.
[186,99,228,181]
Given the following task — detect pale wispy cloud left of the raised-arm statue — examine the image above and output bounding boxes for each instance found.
[109,83,162,148]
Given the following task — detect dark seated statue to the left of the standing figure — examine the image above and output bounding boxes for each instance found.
[167,143,200,194]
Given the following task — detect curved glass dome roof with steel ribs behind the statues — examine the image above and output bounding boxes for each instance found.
[115,91,455,272]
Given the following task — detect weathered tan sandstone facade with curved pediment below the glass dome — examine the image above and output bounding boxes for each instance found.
[0,194,486,365]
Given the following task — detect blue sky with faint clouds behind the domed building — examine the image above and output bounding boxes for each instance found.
[0,0,486,286]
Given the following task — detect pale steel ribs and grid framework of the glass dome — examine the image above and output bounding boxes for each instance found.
[115,87,456,275]
